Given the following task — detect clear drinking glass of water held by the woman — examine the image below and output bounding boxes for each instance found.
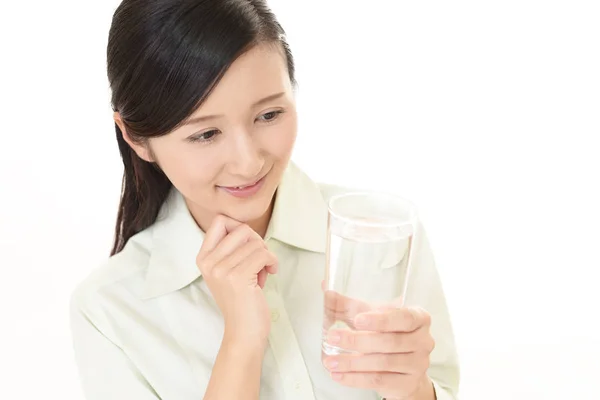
[321,192,417,357]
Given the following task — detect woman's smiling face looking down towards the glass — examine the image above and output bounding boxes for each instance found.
[126,46,297,228]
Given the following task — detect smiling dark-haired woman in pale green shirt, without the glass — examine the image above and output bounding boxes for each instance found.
[71,0,458,400]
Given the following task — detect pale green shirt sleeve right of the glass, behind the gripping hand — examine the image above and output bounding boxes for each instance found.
[406,223,460,400]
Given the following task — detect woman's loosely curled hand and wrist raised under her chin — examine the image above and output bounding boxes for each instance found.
[196,215,277,346]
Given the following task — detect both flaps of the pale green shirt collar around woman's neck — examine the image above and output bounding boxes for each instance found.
[142,162,327,299]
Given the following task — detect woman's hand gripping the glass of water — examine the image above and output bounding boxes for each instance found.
[323,292,435,400]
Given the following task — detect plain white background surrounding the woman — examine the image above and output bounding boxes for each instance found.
[0,0,600,400]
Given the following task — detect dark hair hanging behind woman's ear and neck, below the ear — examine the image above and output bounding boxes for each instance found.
[110,124,172,256]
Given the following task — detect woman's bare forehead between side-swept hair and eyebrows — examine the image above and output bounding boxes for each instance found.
[194,45,292,115]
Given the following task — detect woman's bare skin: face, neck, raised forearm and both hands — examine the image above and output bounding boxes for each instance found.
[114,45,435,400]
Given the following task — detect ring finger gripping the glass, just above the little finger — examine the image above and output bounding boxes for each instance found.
[324,353,429,375]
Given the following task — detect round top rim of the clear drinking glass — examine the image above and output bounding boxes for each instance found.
[327,190,418,228]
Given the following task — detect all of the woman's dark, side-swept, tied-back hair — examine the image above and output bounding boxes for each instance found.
[107,0,295,255]
